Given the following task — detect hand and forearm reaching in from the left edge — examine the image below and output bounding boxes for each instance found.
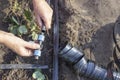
[0,31,40,56]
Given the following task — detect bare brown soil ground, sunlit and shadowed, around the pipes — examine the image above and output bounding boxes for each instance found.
[0,0,120,80]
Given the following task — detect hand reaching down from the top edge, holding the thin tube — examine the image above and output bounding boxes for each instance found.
[33,0,53,30]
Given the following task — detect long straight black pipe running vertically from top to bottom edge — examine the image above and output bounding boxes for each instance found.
[52,0,59,80]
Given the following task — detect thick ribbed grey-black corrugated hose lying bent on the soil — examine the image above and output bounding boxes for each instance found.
[59,45,120,80]
